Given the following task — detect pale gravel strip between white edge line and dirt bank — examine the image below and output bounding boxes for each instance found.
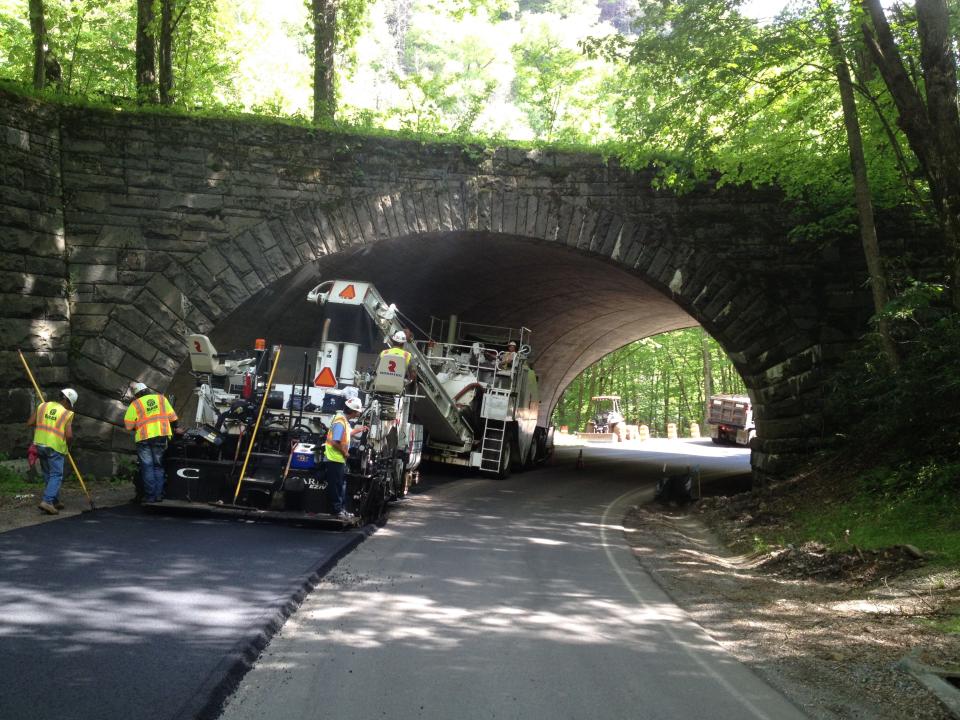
[624,505,960,720]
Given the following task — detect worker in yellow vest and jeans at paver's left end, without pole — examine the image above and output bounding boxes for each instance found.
[123,382,177,504]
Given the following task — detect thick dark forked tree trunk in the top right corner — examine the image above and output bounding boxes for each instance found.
[861,0,960,310]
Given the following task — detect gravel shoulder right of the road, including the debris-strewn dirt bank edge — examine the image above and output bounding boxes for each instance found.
[625,494,960,720]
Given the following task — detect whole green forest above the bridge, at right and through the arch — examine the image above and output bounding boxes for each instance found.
[0,0,960,450]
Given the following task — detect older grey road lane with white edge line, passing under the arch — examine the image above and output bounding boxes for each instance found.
[222,443,804,720]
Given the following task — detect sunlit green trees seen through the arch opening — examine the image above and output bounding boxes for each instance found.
[552,328,746,435]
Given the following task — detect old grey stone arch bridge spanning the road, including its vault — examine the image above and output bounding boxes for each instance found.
[0,94,869,474]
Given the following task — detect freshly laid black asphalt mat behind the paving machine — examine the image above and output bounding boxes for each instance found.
[0,506,365,720]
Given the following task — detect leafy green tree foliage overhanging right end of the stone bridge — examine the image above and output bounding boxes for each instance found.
[588,0,918,239]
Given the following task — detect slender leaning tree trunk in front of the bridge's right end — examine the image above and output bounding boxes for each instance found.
[820,0,900,370]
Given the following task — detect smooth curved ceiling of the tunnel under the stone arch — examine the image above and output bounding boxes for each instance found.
[202,232,698,422]
